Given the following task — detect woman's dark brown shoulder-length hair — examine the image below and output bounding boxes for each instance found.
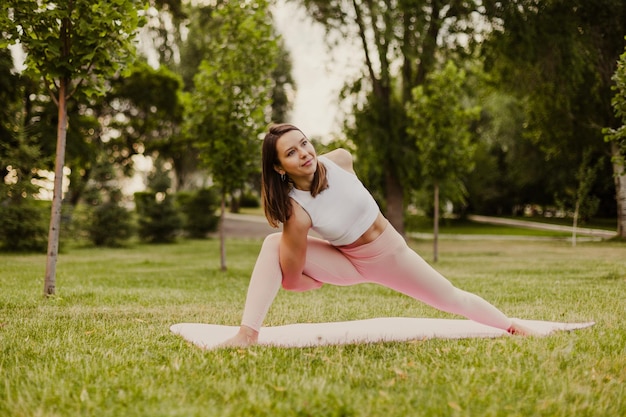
[261,123,328,227]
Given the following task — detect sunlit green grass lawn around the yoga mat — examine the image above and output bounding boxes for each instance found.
[0,236,626,417]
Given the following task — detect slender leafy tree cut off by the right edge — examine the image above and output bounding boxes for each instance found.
[604,39,626,239]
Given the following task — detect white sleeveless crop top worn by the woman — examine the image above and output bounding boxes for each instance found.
[289,156,379,246]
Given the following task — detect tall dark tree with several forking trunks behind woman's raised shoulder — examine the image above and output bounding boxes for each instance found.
[299,0,482,233]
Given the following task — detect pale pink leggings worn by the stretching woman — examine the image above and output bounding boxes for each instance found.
[241,221,512,331]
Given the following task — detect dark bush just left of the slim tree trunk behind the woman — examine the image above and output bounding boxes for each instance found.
[176,188,219,238]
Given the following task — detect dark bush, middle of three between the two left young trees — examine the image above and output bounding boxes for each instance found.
[135,192,182,243]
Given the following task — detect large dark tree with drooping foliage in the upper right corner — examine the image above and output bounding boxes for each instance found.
[483,0,626,237]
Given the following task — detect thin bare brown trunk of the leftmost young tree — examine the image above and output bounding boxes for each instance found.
[43,79,67,296]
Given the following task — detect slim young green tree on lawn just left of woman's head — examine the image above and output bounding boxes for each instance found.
[188,1,277,270]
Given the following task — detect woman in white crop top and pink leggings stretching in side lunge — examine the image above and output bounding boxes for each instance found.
[222,124,532,347]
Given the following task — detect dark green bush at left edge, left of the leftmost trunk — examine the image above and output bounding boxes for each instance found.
[0,200,50,253]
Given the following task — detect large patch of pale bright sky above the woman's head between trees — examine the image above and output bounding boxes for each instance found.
[273,0,363,141]
